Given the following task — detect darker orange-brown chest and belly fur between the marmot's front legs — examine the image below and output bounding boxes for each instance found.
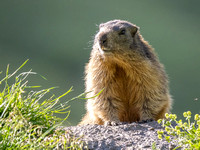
[108,65,147,122]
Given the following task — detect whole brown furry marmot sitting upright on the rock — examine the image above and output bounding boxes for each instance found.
[80,20,172,125]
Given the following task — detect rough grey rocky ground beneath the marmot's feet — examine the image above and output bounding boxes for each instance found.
[62,121,178,150]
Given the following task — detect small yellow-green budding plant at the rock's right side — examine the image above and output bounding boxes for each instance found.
[157,111,200,150]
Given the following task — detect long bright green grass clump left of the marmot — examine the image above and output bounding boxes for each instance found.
[0,61,87,150]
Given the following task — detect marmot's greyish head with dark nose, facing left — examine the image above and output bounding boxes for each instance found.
[94,20,139,54]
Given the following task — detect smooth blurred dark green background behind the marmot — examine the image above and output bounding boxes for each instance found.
[0,0,200,125]
